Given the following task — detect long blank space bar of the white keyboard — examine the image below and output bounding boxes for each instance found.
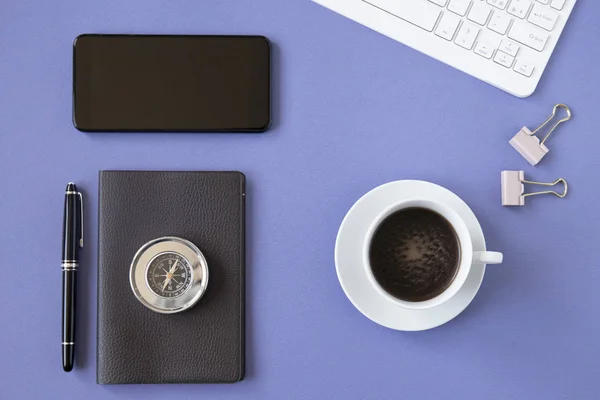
[364,0,441,32]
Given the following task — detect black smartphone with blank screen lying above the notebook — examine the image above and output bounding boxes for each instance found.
[73,34,271,132]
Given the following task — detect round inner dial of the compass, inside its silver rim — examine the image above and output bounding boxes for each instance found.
[146,252,193,298]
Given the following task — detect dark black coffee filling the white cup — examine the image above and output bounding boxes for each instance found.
[369,208,460,302]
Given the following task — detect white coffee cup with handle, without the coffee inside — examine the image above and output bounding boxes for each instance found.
[362,199,503,310]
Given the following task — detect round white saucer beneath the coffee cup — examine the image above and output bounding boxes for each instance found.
[335,181,486,331]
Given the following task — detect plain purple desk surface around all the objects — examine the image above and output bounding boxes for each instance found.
[0,0,600,400]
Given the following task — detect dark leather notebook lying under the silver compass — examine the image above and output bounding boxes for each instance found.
[97,171,245,384]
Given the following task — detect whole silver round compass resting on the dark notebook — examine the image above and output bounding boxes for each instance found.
[129,236,208,314]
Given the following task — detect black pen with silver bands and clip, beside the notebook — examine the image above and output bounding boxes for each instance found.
[62,183,83,372]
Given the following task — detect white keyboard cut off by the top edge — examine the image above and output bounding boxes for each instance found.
[314,0,576,97]
